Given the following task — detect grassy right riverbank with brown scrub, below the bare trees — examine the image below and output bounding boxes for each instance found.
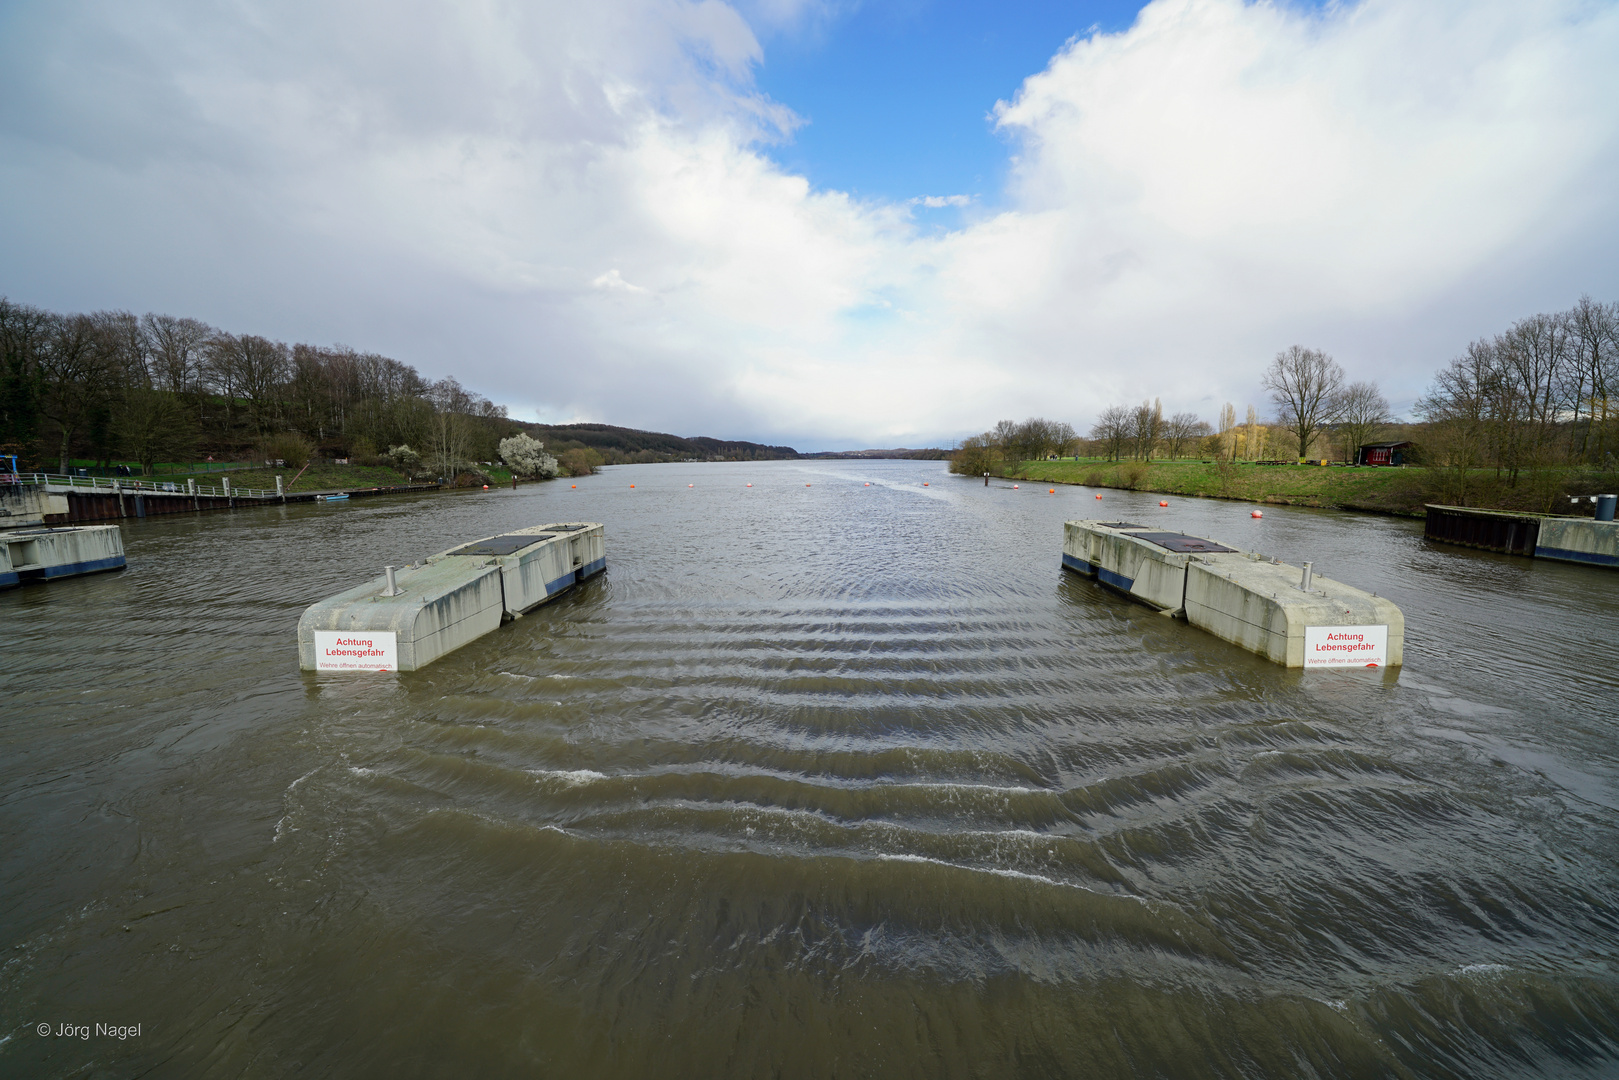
[1005,460,1614,517]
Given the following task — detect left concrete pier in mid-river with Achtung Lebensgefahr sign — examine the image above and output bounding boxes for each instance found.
[298,521,607,672]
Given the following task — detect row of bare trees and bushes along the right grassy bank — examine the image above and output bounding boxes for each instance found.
[952,296,1619,482]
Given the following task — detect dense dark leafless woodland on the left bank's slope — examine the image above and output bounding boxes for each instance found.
[0,298,520,473]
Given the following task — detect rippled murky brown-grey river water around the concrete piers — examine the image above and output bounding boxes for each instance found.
[0,461,1619,1077]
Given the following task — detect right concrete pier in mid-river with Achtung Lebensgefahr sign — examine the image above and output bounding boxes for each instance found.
[1062,521,1405,667]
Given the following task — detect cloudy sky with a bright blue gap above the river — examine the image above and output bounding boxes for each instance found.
[0,0,1619,449]
